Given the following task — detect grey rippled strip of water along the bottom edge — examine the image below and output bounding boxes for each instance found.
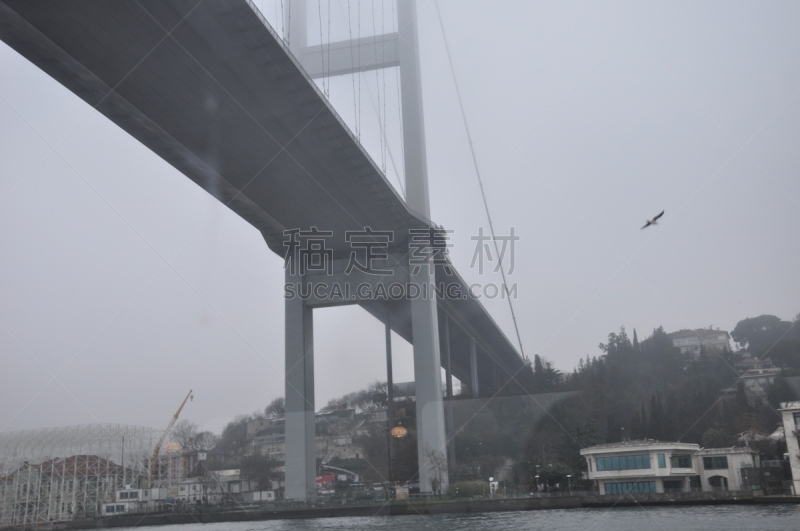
[101,505,800,531]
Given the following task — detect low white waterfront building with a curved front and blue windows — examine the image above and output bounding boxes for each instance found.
[581,440,759,494]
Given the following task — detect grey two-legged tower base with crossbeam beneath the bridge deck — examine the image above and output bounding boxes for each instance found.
[285,254,452,501]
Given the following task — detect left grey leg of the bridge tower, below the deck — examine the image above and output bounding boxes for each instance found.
[285,268,317,501]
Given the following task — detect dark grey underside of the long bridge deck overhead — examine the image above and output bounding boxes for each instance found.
[0,0,522,381]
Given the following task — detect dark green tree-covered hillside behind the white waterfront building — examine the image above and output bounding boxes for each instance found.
[218,315,800,485]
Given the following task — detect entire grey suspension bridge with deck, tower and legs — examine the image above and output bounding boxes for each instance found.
[0,0,524,500]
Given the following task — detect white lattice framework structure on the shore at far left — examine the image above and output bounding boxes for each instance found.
[0,424,163,528]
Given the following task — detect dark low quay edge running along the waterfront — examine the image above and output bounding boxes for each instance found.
[3,492,800,531]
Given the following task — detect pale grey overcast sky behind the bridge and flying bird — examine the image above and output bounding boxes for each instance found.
[0,0,800,431]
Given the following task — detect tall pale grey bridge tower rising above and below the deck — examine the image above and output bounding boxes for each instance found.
[284,0,446,501]
